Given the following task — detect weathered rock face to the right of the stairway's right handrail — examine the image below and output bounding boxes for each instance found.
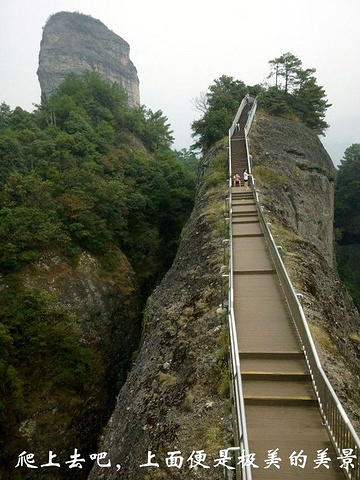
[250,113,360,431]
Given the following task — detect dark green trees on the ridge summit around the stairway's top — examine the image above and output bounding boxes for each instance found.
[192,53,330,151]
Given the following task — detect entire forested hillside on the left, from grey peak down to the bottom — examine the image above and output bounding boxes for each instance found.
[0,73,196,479]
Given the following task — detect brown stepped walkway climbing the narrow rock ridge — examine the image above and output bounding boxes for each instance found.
[231,126,345,480]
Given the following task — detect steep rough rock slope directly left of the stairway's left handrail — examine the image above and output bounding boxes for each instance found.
[89,141,231,480]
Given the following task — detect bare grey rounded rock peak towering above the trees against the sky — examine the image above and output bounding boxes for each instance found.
[37,12,140,107]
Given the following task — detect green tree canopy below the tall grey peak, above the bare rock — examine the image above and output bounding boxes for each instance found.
[0,72,195,280]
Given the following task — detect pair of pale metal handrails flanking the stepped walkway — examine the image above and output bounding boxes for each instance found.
[229,95,360,480]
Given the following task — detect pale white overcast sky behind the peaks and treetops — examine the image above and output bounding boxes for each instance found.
[0,0,360,164]
